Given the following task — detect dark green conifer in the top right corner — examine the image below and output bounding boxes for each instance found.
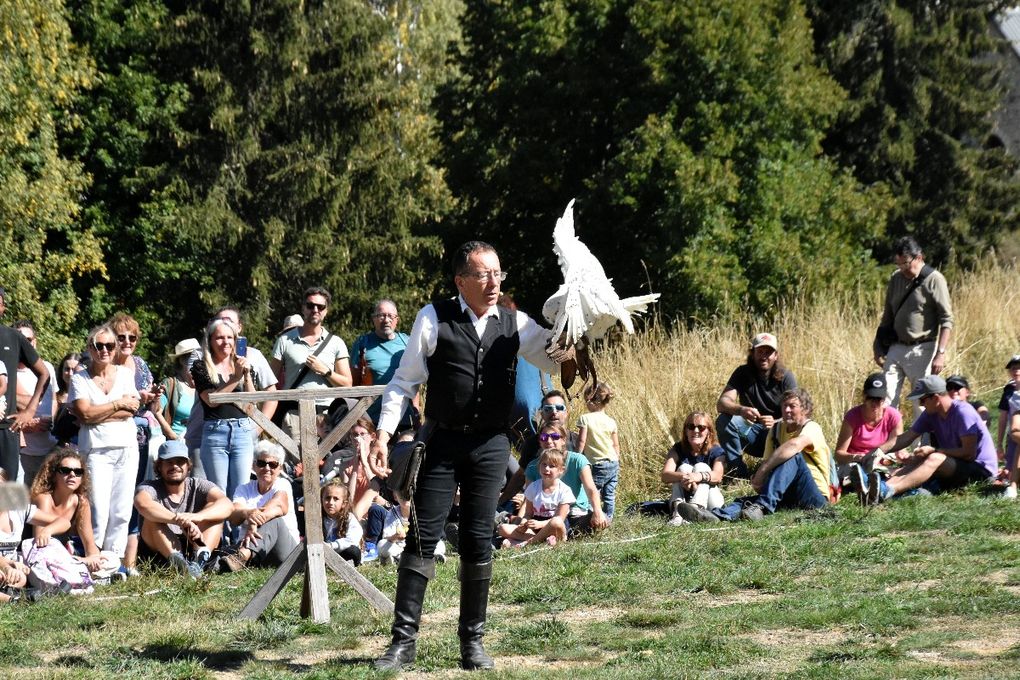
[808,0,1020,265]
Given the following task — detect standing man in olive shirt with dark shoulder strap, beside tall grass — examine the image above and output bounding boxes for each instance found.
[874,237,953,408]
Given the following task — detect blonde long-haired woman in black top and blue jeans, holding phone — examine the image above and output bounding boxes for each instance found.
[192,319,257,498]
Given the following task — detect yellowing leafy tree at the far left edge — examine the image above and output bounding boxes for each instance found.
[0,0,103,356]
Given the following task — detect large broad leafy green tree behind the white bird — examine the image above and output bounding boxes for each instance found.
[440,0,885,322]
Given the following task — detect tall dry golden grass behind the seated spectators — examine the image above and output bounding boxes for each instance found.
[583,264,1020,501]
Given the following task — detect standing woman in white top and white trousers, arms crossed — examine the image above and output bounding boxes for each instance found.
[67,325,139,558]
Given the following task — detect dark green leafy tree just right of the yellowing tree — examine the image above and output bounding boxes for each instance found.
[63,0,194,361]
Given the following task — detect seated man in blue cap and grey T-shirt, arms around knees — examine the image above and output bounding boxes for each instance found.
[135,439,234,578]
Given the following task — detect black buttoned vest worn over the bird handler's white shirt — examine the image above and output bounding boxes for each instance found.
[425,299,520,429]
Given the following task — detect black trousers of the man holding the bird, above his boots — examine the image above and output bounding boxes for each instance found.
[404,428,510,564]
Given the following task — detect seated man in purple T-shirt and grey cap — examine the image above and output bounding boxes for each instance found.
[851,375,999,505]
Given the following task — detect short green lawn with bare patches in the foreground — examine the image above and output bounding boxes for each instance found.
[0,490,1020,679]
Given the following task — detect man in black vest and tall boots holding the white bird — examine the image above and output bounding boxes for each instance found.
[369,241,572,670]
